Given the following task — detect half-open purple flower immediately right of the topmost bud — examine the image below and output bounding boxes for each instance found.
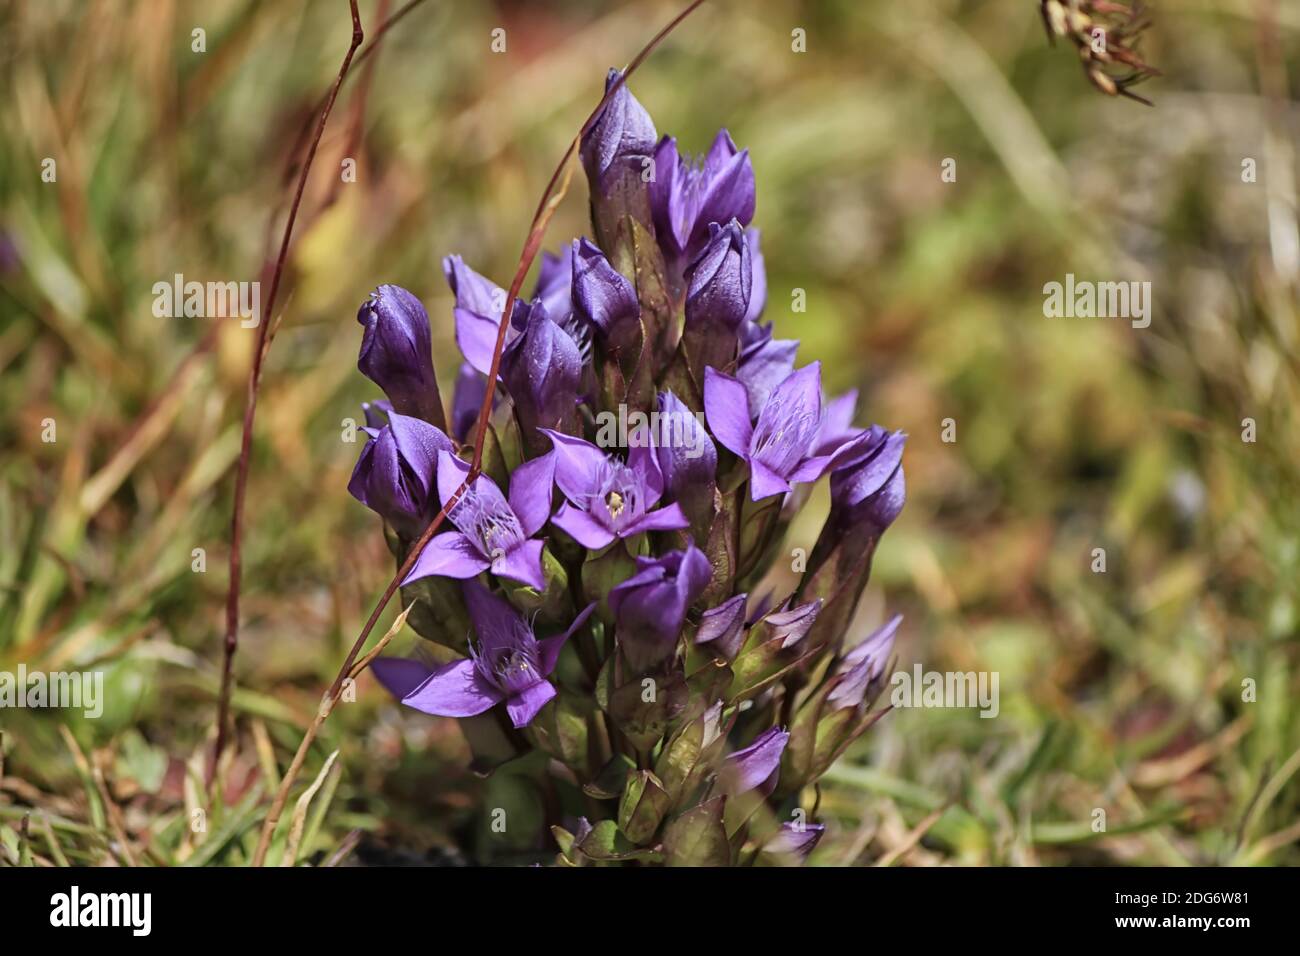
[650,129,754,269]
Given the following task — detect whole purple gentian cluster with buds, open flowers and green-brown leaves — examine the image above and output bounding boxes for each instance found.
[348,72,905,865]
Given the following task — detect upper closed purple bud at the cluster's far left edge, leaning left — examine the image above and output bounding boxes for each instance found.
[356,285,446,428]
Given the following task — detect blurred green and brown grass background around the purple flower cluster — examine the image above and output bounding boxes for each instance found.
[0,0,1300,865]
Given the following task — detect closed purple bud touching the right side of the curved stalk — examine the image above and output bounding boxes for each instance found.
[501,299,582,433]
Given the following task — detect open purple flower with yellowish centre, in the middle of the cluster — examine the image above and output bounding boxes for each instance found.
[540,428,690,550]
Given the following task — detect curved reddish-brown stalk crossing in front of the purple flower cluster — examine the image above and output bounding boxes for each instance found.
[252,0,705,866]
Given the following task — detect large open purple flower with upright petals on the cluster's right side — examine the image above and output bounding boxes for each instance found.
[705,362,865,501]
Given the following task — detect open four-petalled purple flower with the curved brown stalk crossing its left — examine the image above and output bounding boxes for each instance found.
[403,451,555,591]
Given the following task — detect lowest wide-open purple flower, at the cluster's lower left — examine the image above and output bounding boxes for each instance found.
[373,581,595,727]
